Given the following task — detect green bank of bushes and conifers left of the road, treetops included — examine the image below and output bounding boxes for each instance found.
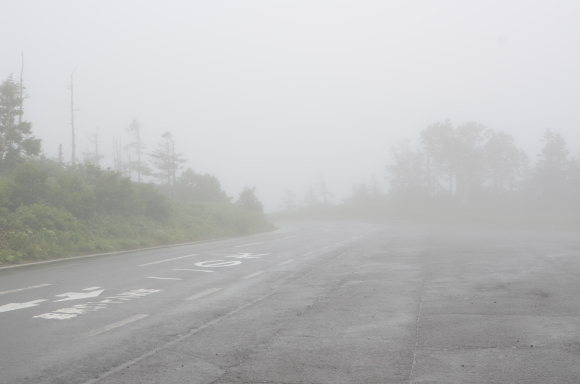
[0,73,273,264]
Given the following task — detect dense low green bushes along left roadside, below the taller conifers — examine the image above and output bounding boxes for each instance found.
[0,161,273,264]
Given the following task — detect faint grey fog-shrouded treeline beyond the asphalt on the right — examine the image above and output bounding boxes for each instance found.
[282,121,580,227]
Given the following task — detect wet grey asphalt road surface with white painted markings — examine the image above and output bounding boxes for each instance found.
[0,222,580,384]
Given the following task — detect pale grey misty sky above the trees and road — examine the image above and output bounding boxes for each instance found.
[0,0,580,211]
